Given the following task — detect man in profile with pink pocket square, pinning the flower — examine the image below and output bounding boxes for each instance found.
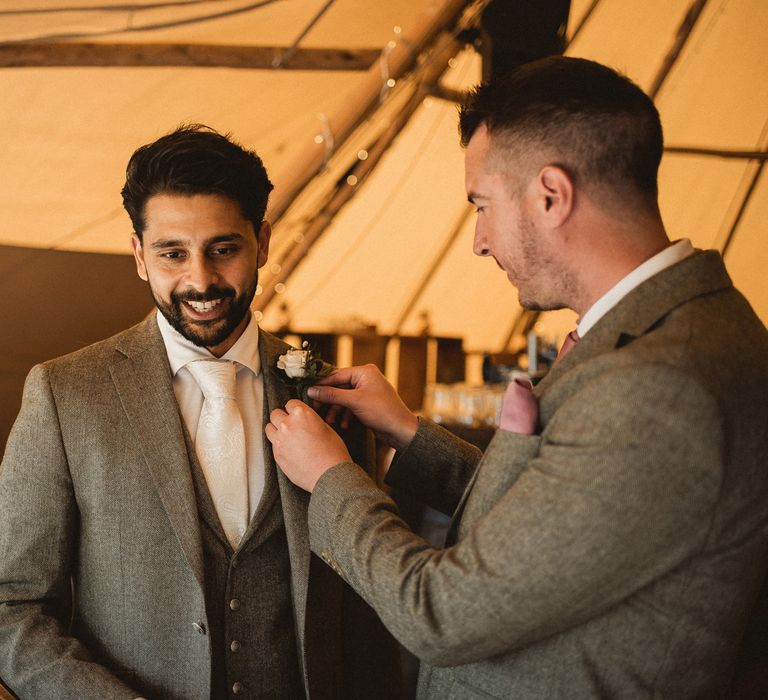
[267,57,768,699]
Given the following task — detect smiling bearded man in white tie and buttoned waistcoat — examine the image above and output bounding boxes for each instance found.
[0,126,399,700]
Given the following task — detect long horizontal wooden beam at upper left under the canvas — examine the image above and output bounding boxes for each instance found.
[0,42,381,71]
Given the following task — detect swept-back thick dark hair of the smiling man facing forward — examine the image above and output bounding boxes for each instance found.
[122,124,272,239]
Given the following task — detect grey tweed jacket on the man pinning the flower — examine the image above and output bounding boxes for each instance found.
[310,251,768,700]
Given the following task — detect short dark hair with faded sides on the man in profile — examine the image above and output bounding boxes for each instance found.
[459,56,663,207]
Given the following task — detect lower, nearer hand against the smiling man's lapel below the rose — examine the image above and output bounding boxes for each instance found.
[264,399,352,492]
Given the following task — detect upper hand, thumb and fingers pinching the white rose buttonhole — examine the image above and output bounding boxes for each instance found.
[307,365,419,450]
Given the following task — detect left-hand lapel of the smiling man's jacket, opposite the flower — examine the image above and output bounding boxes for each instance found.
[110,313,204,587]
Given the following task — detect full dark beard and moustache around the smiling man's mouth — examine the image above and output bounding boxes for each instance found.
[150,275,258,348]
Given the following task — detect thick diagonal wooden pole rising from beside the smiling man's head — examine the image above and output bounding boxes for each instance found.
[267,0,467,223]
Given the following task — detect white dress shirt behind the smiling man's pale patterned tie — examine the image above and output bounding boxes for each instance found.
[157,311,264,522]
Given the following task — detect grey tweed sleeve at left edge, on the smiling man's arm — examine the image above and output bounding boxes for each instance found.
[0,365,139,700]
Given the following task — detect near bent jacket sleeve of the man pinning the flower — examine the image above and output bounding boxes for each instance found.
[309,366,723,666]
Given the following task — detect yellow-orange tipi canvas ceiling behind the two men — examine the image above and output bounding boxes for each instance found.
[0,0,768,351]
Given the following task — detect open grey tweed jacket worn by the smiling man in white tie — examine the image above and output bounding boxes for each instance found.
[0,314,399,700]
